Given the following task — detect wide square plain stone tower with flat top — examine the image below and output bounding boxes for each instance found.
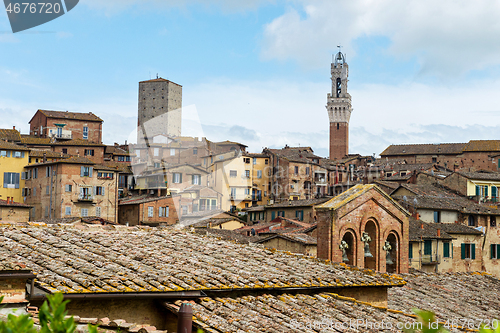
[137,77,182,143]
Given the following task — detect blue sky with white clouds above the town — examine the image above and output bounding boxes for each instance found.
[0,0,500,157]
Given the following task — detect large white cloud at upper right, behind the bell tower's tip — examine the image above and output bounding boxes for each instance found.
[262,0,500,77]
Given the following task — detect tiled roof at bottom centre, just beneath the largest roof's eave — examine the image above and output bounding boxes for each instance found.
[166,293,415,333]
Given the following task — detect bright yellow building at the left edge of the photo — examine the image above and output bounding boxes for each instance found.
[0,141,29,203]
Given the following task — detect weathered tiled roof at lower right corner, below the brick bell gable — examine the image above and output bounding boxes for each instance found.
[388,272,500,328]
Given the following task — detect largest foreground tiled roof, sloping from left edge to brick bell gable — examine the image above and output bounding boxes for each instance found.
[0,226,404,293]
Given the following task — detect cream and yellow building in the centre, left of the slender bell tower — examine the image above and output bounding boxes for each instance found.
[210,151,269,210]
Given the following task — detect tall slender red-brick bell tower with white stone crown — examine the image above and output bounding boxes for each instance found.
[326,51,352,160]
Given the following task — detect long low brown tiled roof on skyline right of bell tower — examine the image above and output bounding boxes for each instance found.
[380,143,467,157]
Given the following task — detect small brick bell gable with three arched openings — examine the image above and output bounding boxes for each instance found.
[316,185,409,273]
